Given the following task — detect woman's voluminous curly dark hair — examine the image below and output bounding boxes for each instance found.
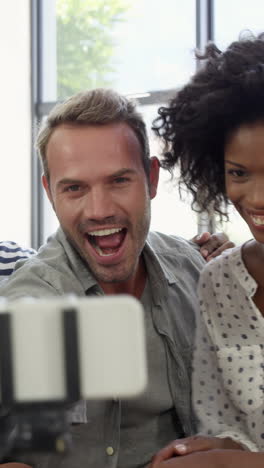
[153,33,264,216]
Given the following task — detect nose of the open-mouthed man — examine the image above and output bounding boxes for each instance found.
[84,188,114,220]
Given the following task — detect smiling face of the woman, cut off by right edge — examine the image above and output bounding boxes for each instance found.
[225,122,264,243]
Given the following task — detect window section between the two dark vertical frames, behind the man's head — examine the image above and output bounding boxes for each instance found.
[38,0,197,243]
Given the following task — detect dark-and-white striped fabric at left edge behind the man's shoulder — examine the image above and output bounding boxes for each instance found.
[0,241,36,277]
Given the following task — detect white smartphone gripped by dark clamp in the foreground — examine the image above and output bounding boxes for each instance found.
[0,295,147,405]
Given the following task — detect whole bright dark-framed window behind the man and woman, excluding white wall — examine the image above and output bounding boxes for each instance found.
[32,0,262,247]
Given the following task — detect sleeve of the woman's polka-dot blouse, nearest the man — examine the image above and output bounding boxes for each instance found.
[192,268,258,451]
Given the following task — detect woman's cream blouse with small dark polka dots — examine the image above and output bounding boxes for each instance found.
[193,247,264,451]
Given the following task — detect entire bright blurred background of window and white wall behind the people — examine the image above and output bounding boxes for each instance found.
[0,0,264,248]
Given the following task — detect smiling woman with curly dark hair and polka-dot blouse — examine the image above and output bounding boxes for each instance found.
[151,34,264,468]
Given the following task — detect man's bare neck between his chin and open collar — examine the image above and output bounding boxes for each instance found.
[99,257,147,299]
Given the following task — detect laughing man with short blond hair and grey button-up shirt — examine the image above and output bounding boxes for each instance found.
[0,89,231,468]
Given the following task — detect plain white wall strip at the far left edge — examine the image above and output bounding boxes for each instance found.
[0,0,31,246]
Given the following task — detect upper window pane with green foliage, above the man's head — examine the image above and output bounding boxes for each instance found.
[56,0,195,98]
